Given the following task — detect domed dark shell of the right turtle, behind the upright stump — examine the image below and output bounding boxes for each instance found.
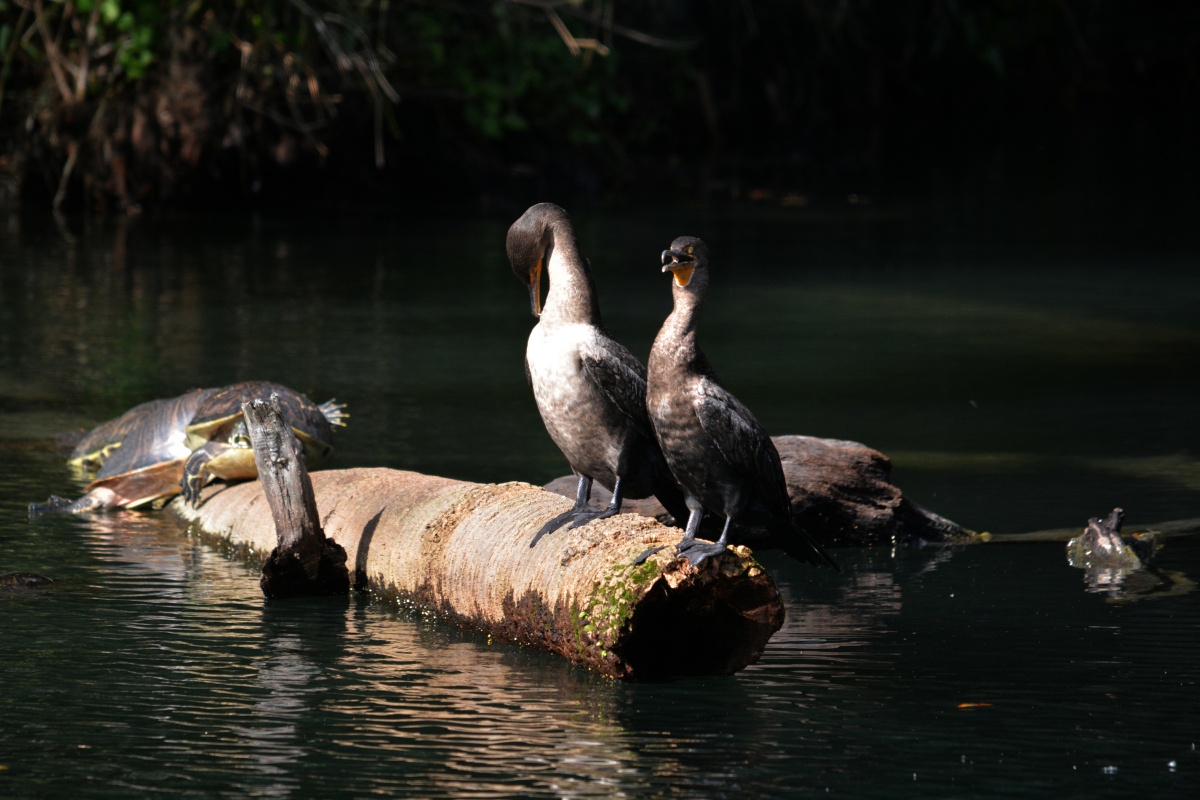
[187,380,342,468]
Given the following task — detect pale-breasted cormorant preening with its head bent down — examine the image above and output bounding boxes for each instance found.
[508,203,688,547]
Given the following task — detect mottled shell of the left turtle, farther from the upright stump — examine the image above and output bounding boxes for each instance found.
[85,389,214,507]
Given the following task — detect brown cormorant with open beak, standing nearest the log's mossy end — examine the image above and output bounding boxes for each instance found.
[638,236,838,569]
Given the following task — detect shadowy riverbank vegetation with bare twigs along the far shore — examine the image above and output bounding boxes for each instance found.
[0,0,1200,211]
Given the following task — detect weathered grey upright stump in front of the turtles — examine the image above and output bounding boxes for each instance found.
[241,393,350,597]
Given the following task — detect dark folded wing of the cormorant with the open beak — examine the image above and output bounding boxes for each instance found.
[696,377,791,509]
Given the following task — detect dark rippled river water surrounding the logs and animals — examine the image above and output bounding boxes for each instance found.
[0,201,1200,798]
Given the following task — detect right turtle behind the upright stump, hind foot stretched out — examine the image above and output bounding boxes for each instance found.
[181,380,347,505]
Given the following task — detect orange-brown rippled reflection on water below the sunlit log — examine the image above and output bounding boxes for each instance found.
[326,608,635,796]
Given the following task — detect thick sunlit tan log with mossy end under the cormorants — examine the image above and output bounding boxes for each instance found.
[169,469,784,678]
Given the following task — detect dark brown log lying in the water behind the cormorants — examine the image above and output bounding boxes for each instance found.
[546,435,973,546]
